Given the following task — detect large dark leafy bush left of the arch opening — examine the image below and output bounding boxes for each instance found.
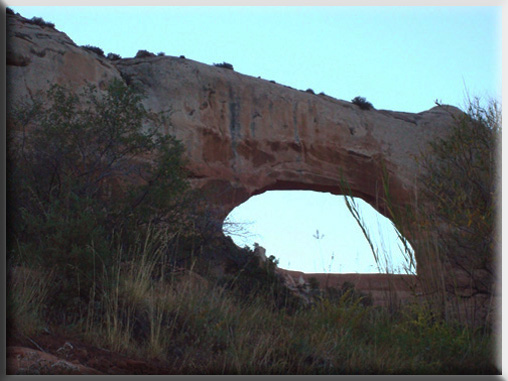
[9,80,187,314]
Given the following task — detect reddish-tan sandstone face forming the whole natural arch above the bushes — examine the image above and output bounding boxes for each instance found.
[7,11,460,274]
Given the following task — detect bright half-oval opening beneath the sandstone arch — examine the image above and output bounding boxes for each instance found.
[223,190,416,275]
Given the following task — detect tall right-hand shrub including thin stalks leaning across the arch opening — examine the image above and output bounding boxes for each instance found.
[344,99,502,330]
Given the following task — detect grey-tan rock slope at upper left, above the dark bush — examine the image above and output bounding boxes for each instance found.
[6,14,120,107]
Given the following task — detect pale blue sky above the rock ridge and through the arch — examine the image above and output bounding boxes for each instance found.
[6,2,502,272]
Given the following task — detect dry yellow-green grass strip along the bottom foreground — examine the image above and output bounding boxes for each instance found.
[7,248,497,374]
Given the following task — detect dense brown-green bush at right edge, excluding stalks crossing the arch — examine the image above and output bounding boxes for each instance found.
[419,99,501,296]
